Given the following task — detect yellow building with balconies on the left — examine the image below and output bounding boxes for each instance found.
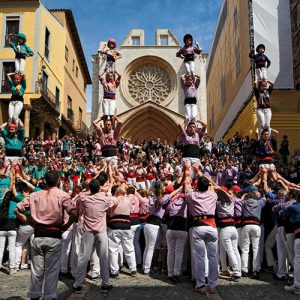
[0,0,91,138]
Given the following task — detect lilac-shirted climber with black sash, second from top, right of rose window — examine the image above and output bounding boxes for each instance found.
[181,74,200,123]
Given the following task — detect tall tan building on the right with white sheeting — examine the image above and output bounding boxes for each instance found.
[206,0,300,154]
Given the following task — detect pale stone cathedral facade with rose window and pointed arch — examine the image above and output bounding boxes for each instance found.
[91,29,207,141]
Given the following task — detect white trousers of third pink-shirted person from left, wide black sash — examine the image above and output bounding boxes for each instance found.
[108,229,136,274]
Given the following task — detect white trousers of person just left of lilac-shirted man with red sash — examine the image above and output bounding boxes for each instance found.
[167,229,188,277]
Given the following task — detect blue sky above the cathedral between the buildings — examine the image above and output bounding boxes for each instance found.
[41,0,222,111]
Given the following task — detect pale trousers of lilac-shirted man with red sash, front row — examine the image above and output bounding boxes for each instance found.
[191,226,218,288]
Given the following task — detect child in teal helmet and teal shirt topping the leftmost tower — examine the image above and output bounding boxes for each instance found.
[9,33,34,75]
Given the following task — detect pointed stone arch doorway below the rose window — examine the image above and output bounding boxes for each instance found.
[121,105,179,142]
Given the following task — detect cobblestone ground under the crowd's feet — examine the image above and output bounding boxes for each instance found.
[0,271,299,300]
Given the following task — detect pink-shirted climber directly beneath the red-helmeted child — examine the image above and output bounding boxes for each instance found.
[99,71,121,124]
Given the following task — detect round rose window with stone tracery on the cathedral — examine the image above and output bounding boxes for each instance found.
[128,64,172,103]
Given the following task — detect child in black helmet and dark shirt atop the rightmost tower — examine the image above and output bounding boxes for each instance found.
[249,44,271,81]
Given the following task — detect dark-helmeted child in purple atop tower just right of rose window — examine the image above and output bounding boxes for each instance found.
[176,34,202,77]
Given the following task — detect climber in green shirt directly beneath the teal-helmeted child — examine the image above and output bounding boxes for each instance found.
[6,73,26,125]
